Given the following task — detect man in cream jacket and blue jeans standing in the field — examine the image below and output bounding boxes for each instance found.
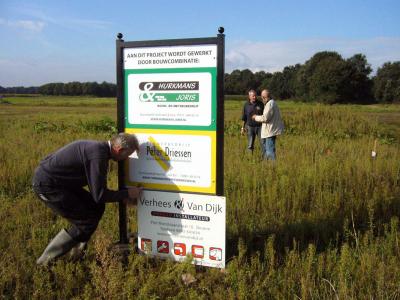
[252,90,284,160]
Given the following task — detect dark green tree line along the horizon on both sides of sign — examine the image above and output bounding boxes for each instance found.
[0,51,400,104]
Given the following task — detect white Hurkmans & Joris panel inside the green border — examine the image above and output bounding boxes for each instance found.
[127,72,212,126]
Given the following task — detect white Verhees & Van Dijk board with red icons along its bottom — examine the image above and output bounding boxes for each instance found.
[138,191,226,268]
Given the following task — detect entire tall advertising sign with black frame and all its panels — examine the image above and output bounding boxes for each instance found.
[117,28,226,268]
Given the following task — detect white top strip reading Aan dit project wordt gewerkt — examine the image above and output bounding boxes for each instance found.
[124,45,217,69]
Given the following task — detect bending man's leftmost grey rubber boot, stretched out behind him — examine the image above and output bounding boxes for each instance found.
[36,229,79,265]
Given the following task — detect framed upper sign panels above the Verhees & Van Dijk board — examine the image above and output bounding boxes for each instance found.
[122,39,223,195]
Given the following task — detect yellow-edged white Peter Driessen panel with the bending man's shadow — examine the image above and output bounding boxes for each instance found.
[128,130,215,193]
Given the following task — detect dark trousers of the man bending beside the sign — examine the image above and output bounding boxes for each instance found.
[33,186,105,242]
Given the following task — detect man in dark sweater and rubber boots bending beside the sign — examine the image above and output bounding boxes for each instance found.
[33,133,141,265]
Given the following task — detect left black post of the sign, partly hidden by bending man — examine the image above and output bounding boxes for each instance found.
[116,33,128,244]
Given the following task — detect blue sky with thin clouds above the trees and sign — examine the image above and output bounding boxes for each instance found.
[0,0,400,87]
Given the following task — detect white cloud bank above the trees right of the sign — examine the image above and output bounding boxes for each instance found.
[225,37,400,72]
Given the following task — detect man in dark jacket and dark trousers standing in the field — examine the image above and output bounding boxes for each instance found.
[240,90,264,152]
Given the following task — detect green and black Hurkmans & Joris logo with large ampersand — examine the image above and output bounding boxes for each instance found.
[139,81,199,102]
